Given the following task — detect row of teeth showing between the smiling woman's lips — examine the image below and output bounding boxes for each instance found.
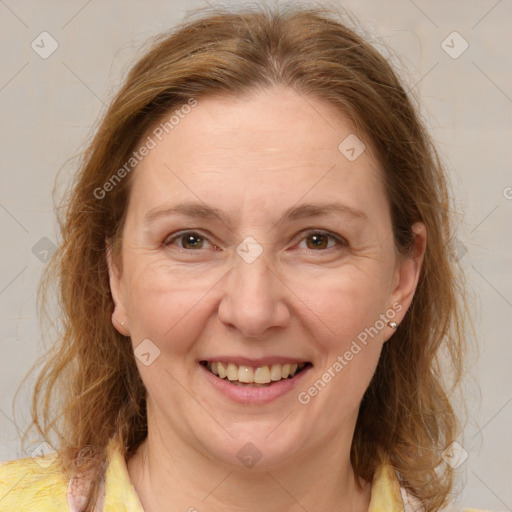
[200,361,312,388]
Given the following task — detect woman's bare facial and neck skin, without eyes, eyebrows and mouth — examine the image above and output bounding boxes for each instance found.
[110,89,426,512]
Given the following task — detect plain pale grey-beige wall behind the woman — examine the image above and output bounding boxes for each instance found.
[0,0,512,510]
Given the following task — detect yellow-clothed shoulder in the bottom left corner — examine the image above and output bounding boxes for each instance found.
[0,454,69,512]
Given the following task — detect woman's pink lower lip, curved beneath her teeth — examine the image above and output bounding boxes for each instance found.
[199,364,312,404]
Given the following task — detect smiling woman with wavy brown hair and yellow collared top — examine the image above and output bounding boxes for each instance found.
[0,4,480,512]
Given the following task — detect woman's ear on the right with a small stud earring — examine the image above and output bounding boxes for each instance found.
[391,222,427,324]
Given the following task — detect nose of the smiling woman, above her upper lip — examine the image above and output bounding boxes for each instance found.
[218,246,290,338]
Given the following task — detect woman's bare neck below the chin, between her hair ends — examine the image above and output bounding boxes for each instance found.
[128,420,371,512]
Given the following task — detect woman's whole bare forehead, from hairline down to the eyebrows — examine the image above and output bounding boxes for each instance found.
[126,88,385,224]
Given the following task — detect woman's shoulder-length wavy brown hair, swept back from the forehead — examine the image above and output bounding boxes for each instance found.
[26,6,465,511]
